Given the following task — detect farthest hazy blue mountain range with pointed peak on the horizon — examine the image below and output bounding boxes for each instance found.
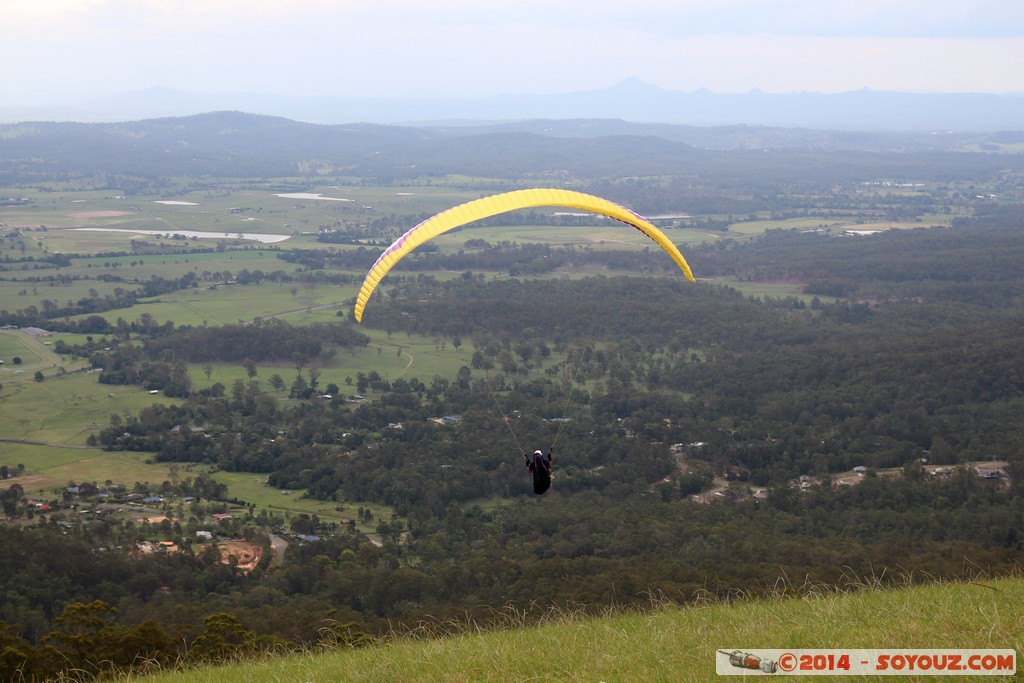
[8,79,1024,132]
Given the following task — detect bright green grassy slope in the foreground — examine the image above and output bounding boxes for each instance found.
[137,578,1024,683]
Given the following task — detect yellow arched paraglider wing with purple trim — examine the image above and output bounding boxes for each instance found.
[354,189,694,323]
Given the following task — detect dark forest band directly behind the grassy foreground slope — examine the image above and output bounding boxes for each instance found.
[0,469,1024,680]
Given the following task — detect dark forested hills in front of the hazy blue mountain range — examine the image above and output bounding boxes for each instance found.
[0,112,1024,188]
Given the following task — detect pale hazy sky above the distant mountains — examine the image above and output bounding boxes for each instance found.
[0,0,1024,106]
